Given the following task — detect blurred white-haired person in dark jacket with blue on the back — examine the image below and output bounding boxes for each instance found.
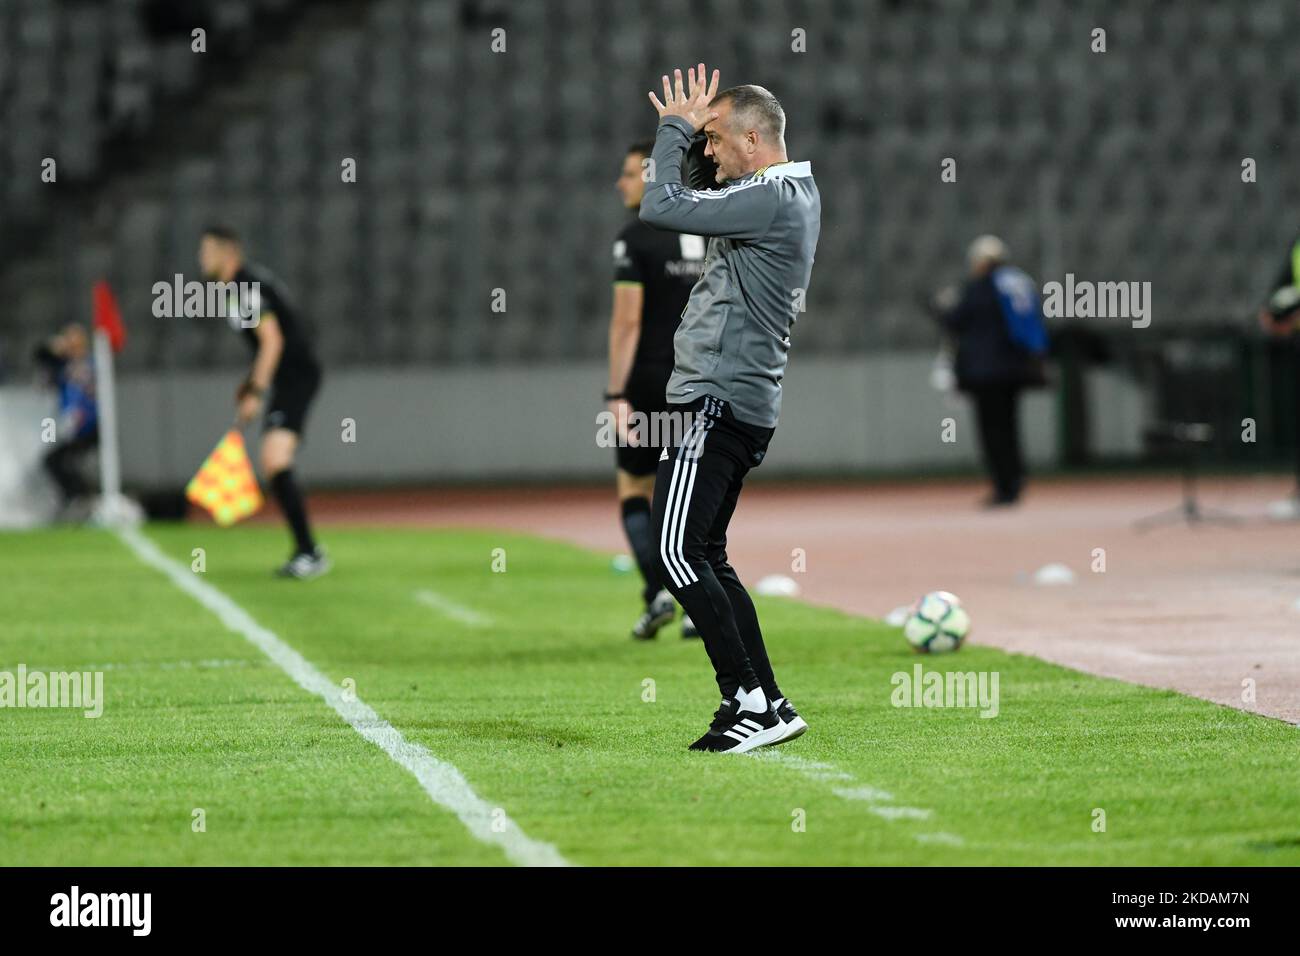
[943,235,1045,507]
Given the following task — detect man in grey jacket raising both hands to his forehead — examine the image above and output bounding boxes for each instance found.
[641,65,822,753]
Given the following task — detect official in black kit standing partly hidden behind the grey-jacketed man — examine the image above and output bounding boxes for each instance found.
[605,140,711,640]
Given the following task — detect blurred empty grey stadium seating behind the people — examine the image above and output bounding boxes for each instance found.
[0,0,1300,369]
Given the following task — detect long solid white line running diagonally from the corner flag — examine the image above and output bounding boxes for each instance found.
[117,528,569,866]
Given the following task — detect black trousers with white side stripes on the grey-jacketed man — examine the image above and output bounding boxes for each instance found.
[653,397,781,698]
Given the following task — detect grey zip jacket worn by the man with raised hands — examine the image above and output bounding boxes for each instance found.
[641,116,822,428]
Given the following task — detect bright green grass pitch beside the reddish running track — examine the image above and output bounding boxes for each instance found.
[0,524,1300,865]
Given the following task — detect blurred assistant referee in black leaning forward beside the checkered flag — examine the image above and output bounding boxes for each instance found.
[199,225,330,579]
